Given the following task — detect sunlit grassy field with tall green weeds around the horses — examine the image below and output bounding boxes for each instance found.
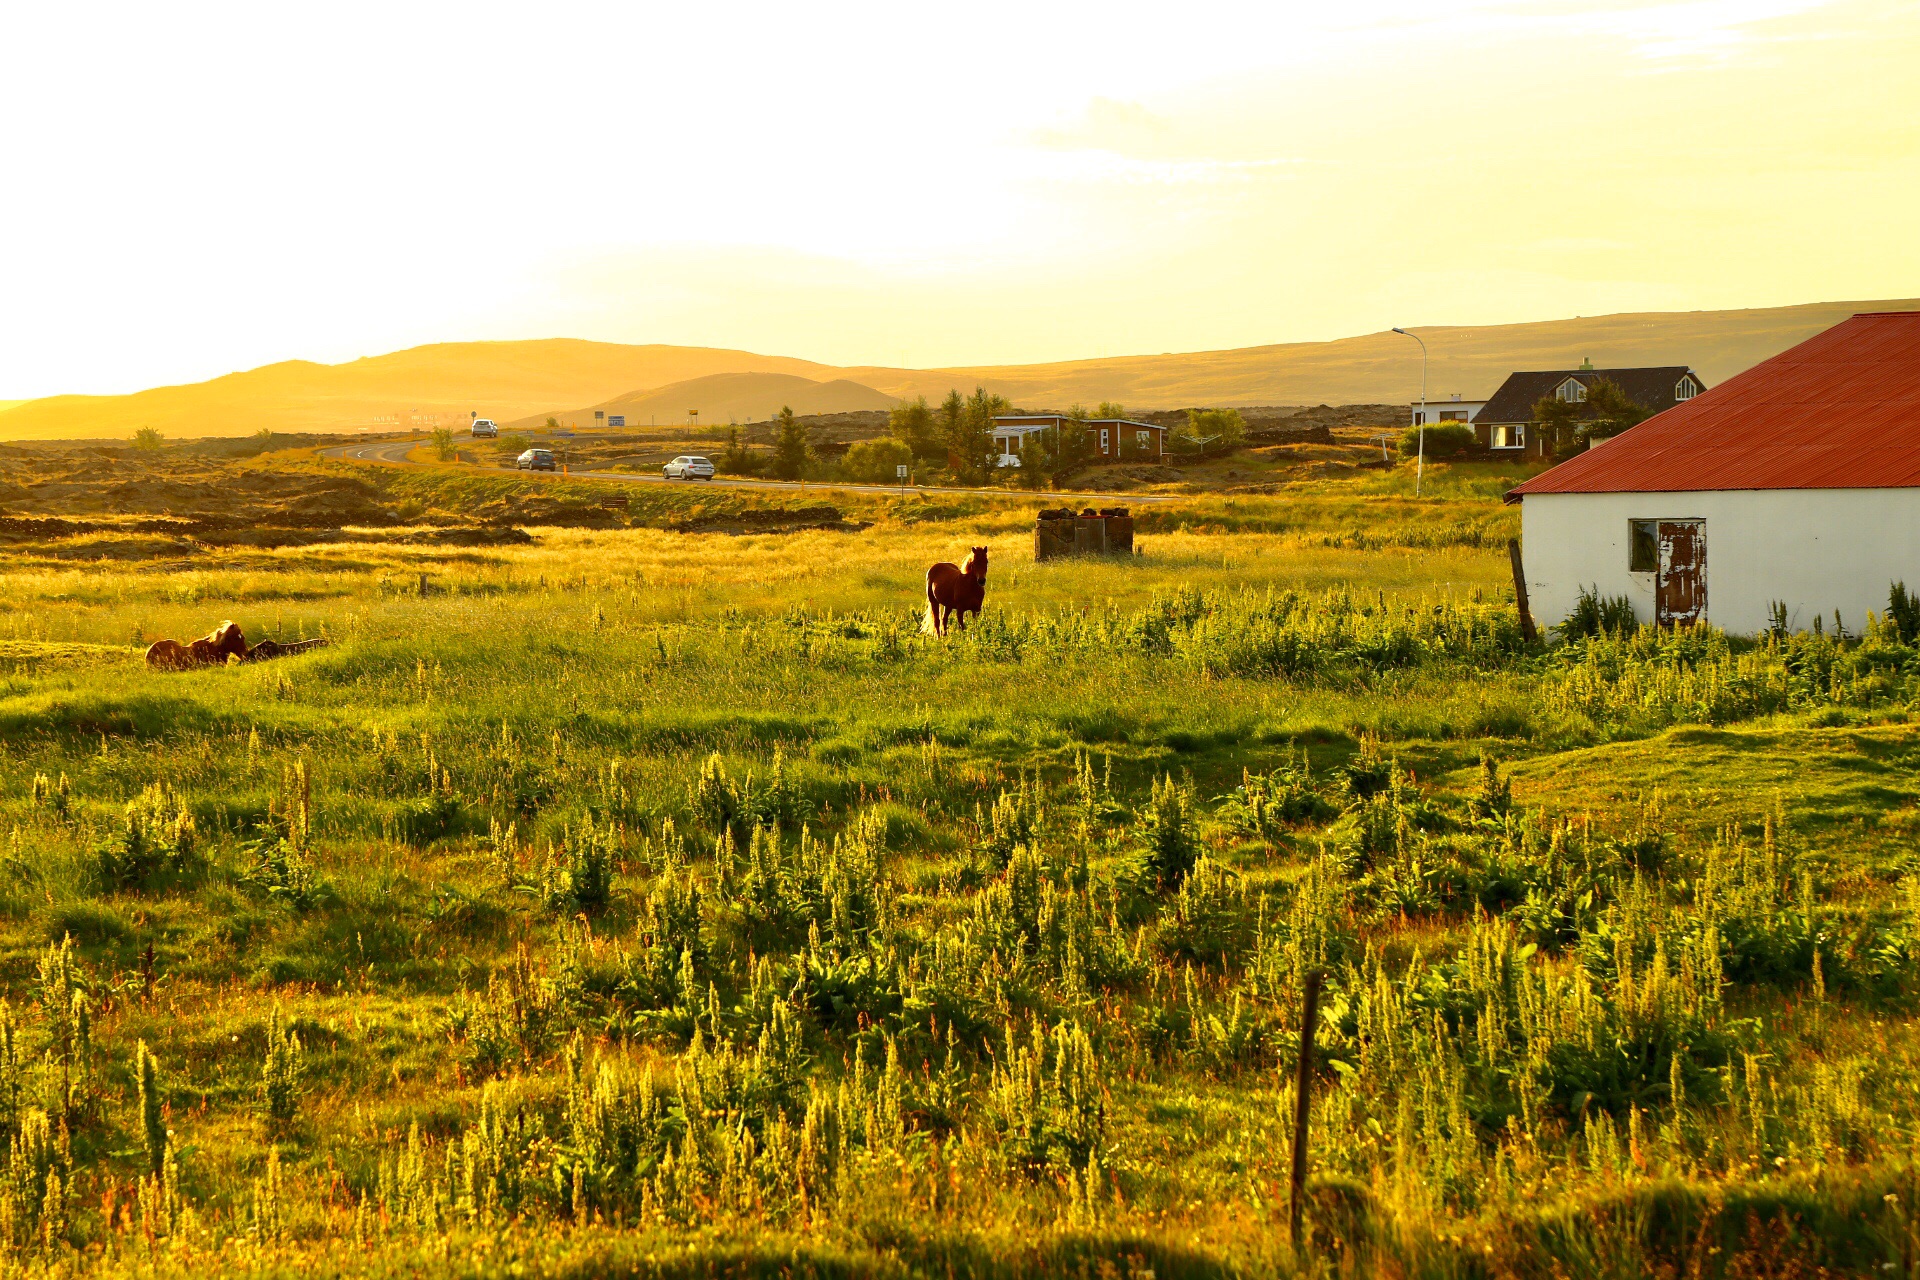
[0,443,1920,1278]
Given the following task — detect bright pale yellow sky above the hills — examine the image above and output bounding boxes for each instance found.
[0,0,1920,399]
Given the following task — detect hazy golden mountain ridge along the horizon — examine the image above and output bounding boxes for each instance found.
[0,299,1920,439]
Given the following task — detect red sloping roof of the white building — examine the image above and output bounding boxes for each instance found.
[1507,311,1920,501]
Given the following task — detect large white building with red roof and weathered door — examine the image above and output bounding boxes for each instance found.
[1507,311,1920,635]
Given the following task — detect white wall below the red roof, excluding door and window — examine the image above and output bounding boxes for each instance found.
[1521,489,1920,635]
